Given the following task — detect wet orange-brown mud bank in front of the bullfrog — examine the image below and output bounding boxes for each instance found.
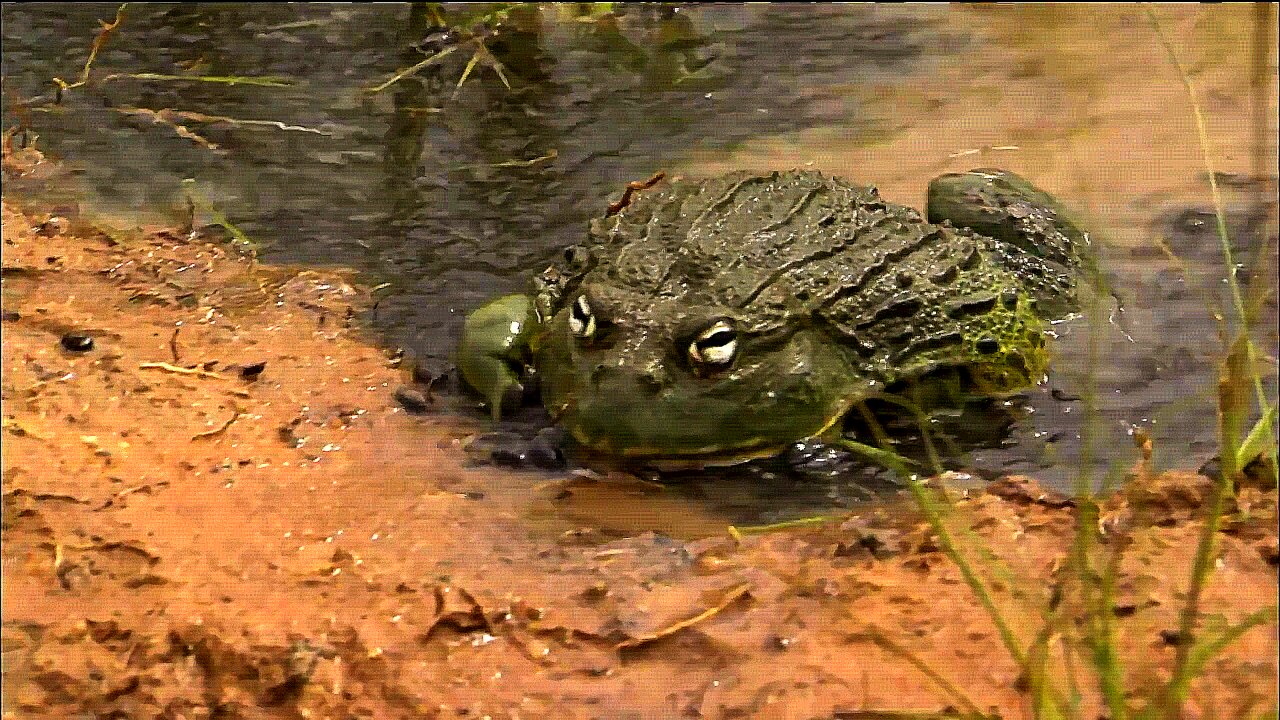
[3,144,1276,719]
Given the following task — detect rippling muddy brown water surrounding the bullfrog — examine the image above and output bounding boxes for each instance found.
[4,4,1277,520]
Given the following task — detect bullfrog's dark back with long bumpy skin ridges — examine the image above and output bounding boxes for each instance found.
[593,172,1071,382]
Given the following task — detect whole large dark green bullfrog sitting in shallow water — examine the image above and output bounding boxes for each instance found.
[458,168,1089,466]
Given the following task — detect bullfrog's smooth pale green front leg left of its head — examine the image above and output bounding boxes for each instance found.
[458,295,536,421]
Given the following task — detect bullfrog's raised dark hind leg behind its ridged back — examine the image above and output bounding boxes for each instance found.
[925,168,1089,269]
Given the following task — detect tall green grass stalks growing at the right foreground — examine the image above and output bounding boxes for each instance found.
[834,8,1277,720]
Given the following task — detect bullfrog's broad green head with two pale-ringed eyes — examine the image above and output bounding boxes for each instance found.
[535,283,867,464]
